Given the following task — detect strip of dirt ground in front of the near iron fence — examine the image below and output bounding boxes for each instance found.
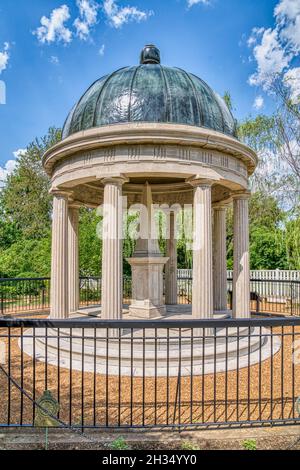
[0,426,300,452]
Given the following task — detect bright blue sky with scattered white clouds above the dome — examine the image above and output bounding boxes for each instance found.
[0,0,300,179]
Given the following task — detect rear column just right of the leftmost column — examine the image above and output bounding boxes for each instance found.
[68,203,80,313]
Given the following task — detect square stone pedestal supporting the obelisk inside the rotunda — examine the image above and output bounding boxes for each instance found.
[127,257,168,319]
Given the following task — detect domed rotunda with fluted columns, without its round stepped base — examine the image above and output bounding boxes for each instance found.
[44,45,257,319]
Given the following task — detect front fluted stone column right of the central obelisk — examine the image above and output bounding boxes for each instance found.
[191,179,213,319]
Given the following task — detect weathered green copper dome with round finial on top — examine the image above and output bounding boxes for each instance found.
[63,45,236,138]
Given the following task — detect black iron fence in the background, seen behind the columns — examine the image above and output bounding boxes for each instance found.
[0,277,300,316]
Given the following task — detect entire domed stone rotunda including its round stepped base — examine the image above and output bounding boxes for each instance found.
[16,45,280,377]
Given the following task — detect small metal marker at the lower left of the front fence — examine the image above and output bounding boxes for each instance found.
[34,390,60,428]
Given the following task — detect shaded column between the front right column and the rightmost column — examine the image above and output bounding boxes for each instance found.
[213,204,227,311]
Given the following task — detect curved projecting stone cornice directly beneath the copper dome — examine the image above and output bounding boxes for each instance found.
[43,123,258,177]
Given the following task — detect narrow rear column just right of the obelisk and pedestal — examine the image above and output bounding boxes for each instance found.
[165,211,177,305]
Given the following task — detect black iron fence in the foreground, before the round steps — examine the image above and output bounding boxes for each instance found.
[0,318,300,431]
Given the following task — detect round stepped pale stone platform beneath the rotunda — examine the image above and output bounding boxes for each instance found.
[19,306,281,377]
